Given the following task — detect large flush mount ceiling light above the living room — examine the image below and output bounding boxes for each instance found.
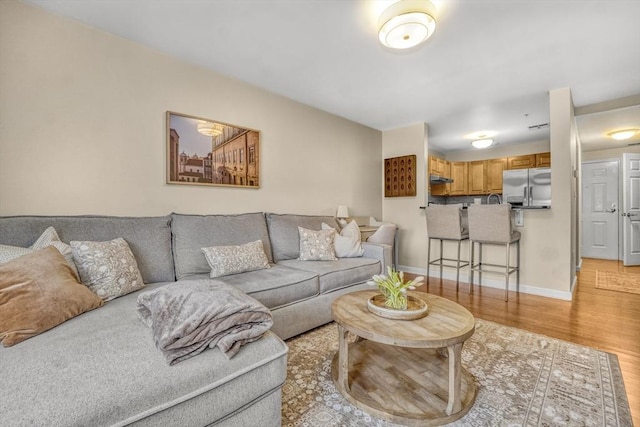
[378,0,436,49]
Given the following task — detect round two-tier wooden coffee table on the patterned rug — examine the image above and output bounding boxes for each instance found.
[331,291,476,426]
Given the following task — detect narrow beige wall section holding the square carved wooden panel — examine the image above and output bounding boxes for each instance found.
[380,123,427,271]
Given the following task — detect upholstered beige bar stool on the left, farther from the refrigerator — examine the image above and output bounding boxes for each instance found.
[425,204,469,291]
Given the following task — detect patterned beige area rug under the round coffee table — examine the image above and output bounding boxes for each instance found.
[282,319,632,427]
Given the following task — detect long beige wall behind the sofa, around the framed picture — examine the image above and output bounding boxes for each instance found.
[0,1,382,217]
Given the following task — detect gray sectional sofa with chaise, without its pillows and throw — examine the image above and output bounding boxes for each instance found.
[0,213,391,426]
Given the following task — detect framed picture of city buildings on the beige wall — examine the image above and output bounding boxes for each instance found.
[166,111,260,188]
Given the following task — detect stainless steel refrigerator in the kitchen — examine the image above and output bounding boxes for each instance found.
[502,168,551,209]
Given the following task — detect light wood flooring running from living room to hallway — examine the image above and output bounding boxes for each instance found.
[407,258,640,426]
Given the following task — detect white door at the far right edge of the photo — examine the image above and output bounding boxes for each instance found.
[621,153,640,265]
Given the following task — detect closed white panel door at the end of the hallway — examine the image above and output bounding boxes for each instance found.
[582,160,619,259]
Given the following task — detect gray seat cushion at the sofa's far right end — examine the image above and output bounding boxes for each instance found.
[278,258,380,294]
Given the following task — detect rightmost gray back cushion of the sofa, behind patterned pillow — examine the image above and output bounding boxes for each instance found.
[267,213,340,262]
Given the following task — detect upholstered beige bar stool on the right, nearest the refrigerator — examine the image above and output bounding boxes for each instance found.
[467,203,520,301]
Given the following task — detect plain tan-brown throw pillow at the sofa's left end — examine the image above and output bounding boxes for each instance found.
[0,246,103,348]
